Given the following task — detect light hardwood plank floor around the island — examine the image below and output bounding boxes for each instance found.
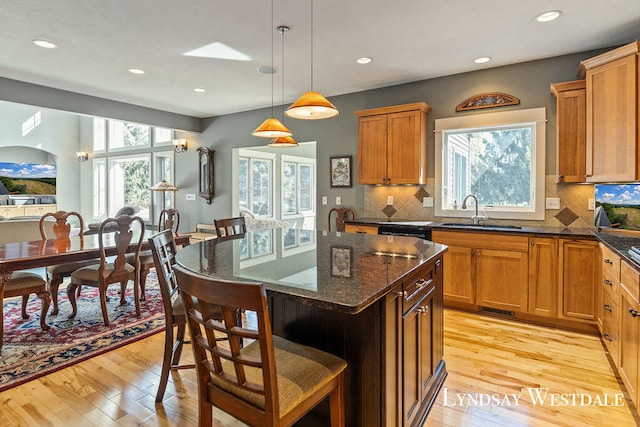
[0,310,637,427]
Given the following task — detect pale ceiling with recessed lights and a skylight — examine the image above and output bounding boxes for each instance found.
[0,0,640,117]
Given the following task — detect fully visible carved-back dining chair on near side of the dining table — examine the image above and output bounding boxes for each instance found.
[67,215,145,326]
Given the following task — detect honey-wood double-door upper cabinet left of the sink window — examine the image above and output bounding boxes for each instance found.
[356,102,431,184]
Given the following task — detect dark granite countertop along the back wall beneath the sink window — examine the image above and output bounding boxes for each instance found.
[345,218,596,238]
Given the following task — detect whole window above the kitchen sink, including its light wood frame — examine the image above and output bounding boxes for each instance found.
[436,108,545,219]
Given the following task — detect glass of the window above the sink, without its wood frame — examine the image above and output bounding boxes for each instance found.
[443,125,535,208]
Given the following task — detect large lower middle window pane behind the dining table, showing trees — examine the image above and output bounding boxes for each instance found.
[109,156,151,220]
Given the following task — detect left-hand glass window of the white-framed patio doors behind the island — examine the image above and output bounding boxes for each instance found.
[238,150,273,217]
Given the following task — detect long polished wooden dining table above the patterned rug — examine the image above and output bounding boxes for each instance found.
[0,230,191,350]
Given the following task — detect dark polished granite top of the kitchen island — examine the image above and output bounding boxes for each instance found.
[176,230,446,314]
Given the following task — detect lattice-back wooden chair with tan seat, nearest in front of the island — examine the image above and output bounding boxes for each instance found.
[174,264,347,427]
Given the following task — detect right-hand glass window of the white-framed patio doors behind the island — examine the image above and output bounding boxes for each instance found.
[282,156,315,217]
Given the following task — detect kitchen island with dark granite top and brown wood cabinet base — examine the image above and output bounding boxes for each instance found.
[172,229,446,427]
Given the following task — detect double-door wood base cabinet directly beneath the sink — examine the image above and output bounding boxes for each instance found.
[432,230,529,311]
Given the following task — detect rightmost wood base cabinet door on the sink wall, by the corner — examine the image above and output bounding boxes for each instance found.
[558,240,601,322]
